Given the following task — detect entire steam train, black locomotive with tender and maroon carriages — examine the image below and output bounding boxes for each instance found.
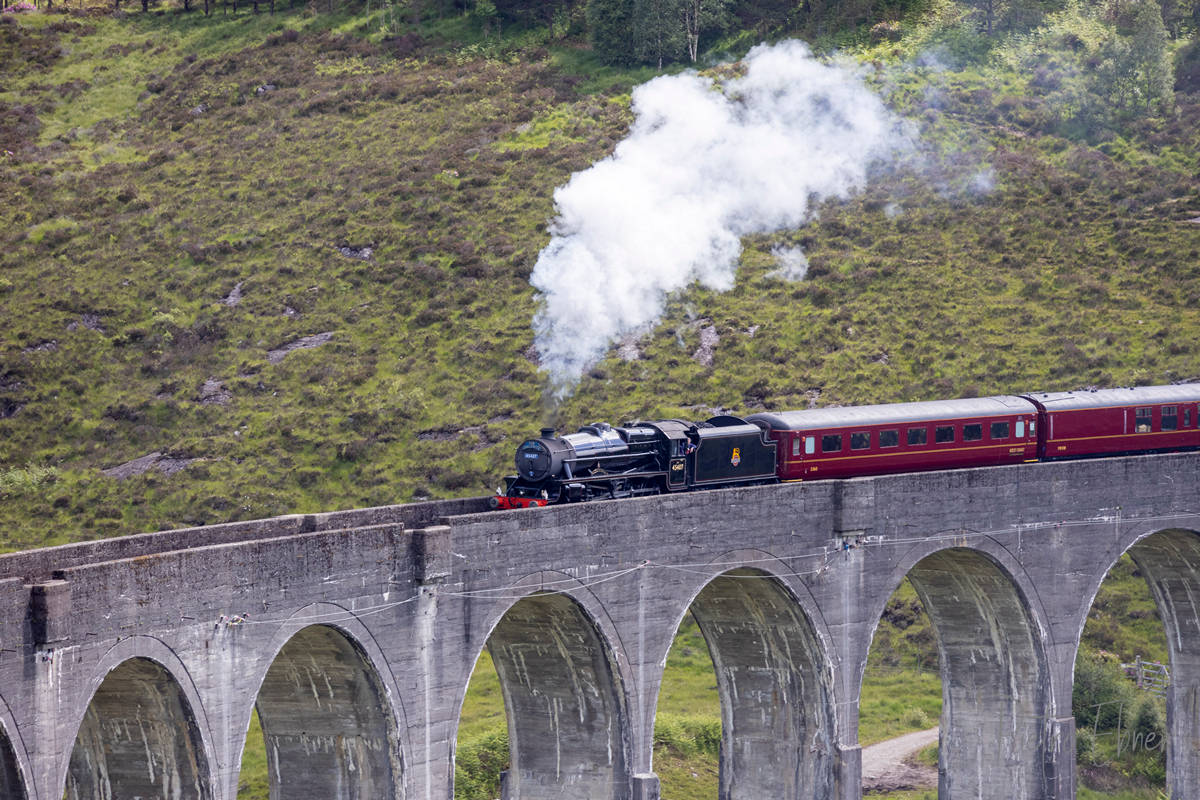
[491,383,1200,509]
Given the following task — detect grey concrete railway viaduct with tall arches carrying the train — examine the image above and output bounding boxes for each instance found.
[0,453,1200,800]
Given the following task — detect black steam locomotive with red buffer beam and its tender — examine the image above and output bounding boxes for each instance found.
[491,416,776,509]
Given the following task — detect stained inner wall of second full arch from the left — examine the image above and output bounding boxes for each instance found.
[246,607,404,800]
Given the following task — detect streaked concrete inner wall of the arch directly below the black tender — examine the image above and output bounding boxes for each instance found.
[677,566,838,800]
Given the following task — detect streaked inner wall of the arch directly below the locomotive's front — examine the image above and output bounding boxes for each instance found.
[475,576,631,800]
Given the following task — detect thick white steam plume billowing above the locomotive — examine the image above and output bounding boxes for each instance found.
[530,42,907,398]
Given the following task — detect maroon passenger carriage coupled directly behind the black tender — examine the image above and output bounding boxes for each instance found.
[746,395,1038,481]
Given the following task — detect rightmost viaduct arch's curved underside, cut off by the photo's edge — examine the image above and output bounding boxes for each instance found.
[1094,528,1200,800]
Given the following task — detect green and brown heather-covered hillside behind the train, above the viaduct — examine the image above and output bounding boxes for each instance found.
[0,5,1200,549]
